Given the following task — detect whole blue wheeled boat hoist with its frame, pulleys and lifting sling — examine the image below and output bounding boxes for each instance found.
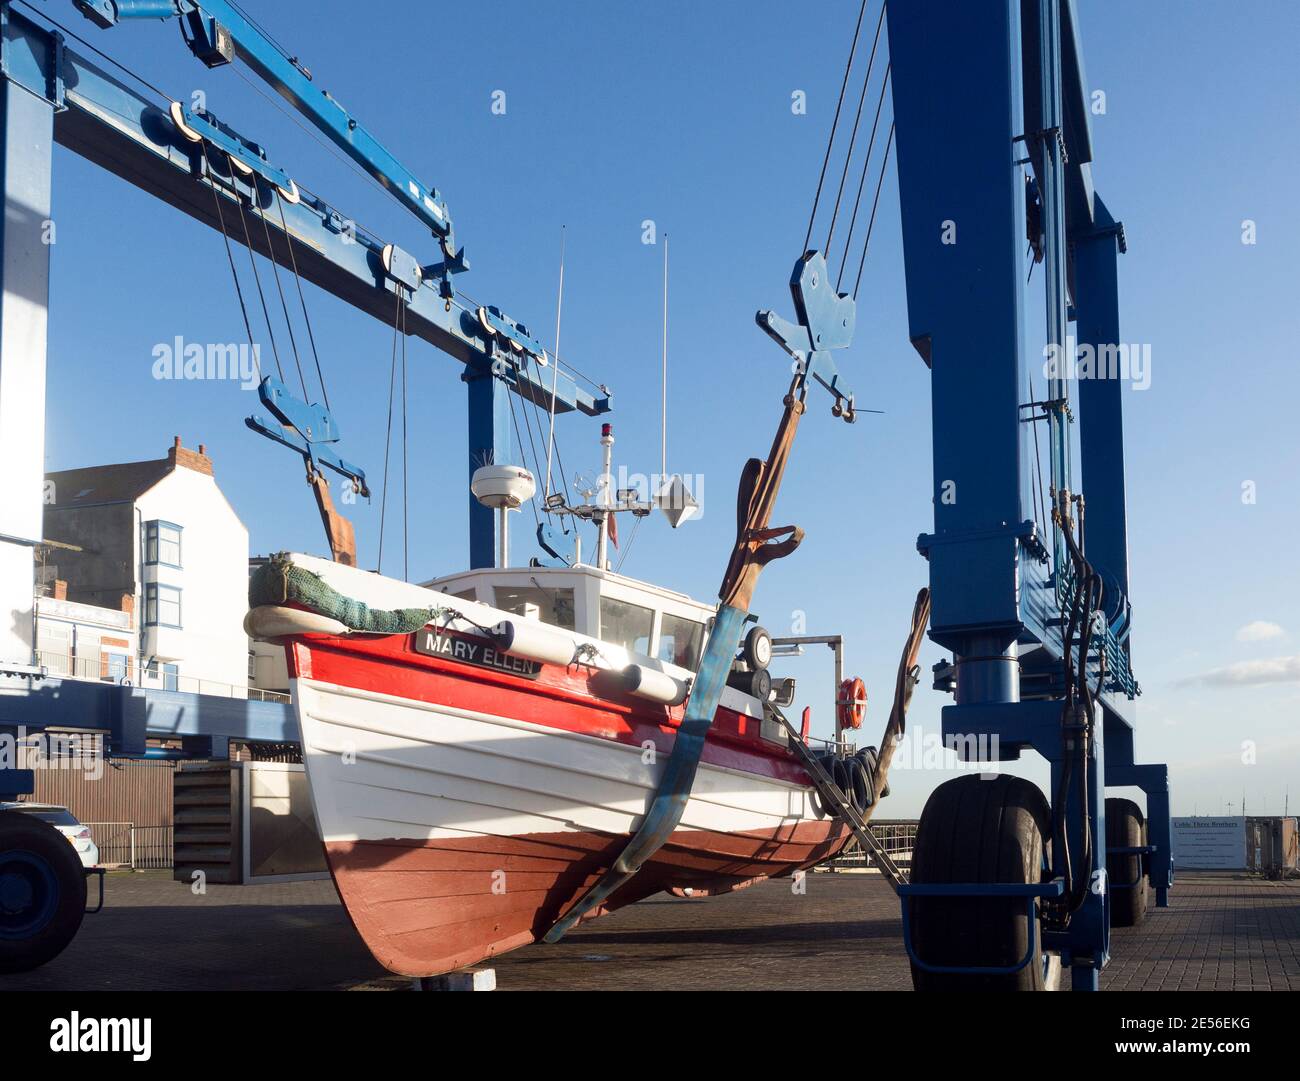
[0,0,1173,989]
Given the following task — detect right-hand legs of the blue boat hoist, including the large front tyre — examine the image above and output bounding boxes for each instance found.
[887,0,1174,990]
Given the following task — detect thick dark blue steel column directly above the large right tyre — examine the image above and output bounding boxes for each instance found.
[888,0,1026,704]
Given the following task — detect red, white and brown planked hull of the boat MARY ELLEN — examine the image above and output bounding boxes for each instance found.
[287,635,848,976]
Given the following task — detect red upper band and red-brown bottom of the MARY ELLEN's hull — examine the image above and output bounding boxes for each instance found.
[289,623,849,976]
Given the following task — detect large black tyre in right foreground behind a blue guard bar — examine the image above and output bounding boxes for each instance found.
[909,774,1061,991]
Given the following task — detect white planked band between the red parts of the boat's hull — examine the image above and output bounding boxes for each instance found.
[293,680,819,842]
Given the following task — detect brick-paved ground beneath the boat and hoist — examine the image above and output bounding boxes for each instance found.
[0,872,1300,990]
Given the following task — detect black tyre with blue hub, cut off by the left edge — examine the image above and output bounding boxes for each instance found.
[0,811,86,973]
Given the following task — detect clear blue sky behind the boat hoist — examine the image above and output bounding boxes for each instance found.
[36,0,1300,817]
